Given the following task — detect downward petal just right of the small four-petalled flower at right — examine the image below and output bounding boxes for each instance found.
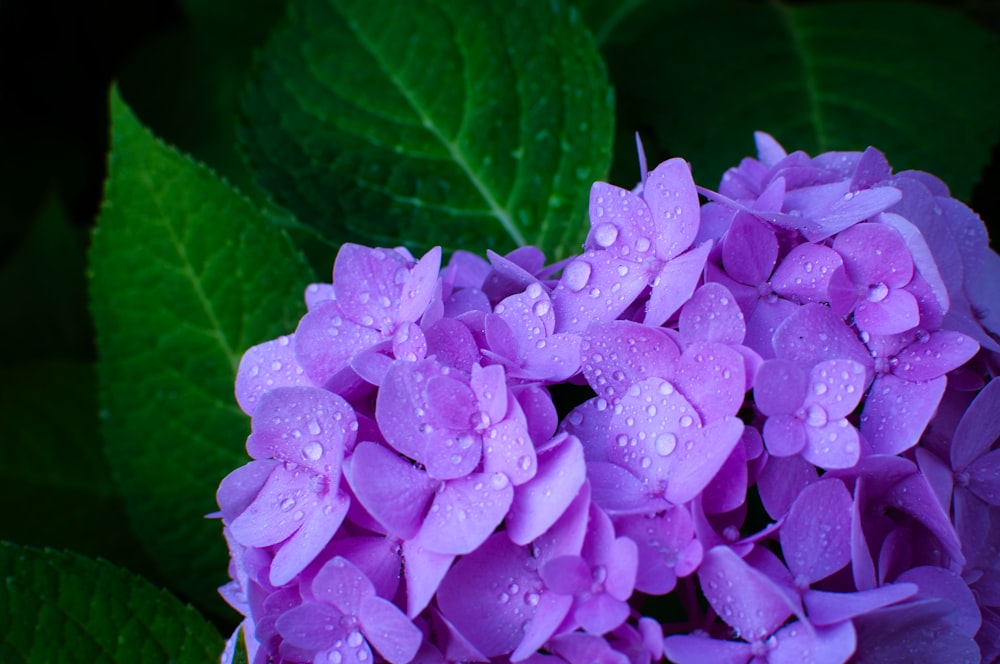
[859,374,947,455]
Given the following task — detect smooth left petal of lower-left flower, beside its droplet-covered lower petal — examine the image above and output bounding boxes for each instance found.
[345,442,436,539]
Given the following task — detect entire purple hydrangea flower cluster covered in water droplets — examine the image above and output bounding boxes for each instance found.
[218,134,1000,664]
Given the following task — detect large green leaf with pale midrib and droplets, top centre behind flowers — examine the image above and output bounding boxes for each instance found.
[242,0,612,257]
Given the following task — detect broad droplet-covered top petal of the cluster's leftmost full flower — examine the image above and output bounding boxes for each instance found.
[247,387,358,474]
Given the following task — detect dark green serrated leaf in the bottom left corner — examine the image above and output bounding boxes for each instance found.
[0,542,223,664]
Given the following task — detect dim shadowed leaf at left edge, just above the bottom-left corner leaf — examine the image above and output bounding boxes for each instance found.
[0,360,155,572]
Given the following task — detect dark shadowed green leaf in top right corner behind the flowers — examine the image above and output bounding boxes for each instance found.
[604,0,1000,198]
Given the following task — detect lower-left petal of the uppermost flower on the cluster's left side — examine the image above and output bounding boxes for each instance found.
[295,301,382,385]
